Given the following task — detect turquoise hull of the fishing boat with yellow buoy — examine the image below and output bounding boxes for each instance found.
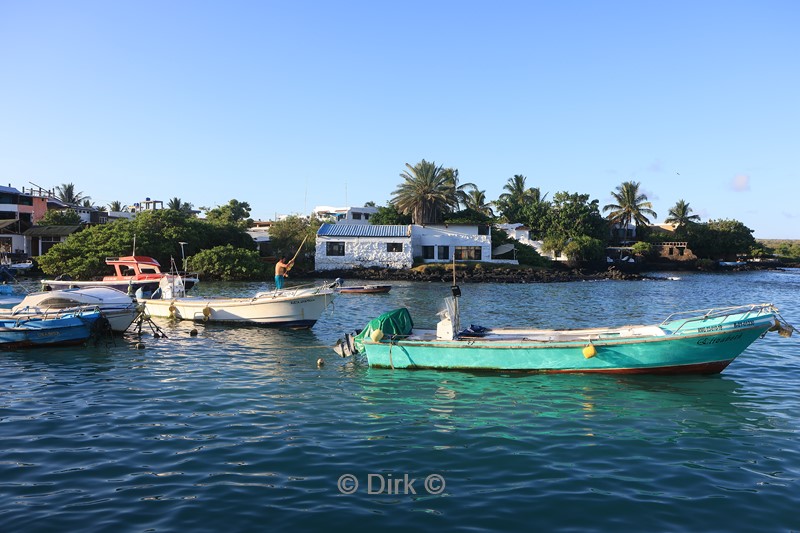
[364,306,775,374]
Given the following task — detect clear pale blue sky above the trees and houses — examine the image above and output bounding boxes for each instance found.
[0,0,800,239]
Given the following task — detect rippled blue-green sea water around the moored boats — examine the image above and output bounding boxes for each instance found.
[0,270,800,532]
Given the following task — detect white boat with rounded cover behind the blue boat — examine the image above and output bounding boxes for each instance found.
[0,287,139,333]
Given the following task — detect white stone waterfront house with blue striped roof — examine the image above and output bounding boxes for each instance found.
[315,224,517,270]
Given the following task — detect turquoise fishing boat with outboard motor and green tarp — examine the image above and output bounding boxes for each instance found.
[336,287,794,374]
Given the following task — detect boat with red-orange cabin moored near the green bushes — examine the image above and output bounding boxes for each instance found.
[42,255,198,296]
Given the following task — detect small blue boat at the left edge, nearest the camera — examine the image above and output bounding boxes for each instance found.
[0,310,102,350]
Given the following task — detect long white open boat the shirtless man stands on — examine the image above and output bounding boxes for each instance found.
[143,284,336,329]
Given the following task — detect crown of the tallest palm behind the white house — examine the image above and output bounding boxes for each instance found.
[391,159,458,225]
